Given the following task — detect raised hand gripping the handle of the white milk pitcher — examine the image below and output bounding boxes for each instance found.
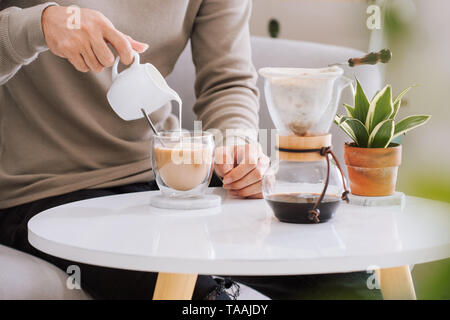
[42,6,148,72]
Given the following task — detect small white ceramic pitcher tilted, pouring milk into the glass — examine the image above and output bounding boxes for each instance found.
[107,51,181,120]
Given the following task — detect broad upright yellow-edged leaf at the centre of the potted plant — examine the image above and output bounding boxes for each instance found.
[365,85,394,133]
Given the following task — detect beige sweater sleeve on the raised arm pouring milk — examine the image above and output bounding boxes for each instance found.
[0,2,57,85]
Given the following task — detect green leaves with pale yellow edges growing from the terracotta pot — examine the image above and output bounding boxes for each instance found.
[334,80,430,148]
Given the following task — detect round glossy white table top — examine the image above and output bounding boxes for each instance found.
[28,188,450,275]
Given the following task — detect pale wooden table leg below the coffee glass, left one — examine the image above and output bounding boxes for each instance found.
[153,272,197,300]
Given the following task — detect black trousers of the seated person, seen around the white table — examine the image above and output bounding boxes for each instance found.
[0,181,380,300]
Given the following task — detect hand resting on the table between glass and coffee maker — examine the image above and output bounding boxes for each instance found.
[214,144,270,199]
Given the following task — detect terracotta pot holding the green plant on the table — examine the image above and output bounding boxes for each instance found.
[344,144,402,197]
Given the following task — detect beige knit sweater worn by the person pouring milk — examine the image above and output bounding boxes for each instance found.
[0,0,258,208]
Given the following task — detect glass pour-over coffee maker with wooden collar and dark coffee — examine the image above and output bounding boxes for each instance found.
[259,67,351,223]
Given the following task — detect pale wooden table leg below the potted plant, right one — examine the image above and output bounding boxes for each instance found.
[377,265,416,300]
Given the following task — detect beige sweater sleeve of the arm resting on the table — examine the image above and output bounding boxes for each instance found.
[191,0,259,144]
